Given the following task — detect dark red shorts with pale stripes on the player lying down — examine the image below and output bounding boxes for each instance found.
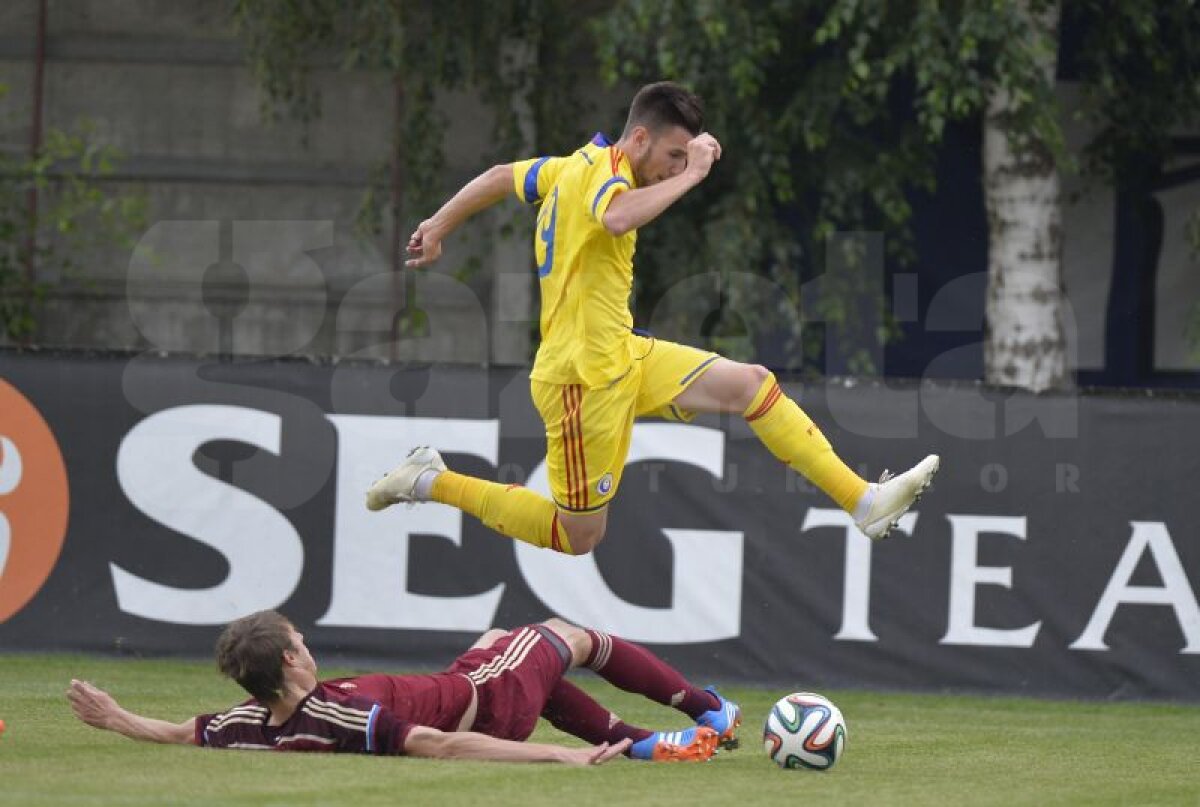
[446,624,571,740]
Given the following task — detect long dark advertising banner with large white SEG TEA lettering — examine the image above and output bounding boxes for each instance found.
[0,352,1200,700]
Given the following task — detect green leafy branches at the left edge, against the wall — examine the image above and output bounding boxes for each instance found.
[0,84,145,341]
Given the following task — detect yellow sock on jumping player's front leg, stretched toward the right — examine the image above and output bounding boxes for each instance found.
[743,373,868,512]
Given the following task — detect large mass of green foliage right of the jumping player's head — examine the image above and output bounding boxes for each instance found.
[600,0,1062,371]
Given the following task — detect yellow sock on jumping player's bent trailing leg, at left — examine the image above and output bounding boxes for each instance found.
[430,471,575,555]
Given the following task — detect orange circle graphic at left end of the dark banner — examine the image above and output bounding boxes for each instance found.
[0,378,71,622]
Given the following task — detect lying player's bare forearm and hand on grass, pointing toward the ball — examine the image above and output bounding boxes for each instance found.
[404,725,630,765]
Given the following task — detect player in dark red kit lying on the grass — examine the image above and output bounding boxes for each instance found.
[67,611,742,765]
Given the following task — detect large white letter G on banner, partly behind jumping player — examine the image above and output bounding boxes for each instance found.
[514,424,743,645]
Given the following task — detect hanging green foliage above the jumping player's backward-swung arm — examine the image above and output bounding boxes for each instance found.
[233,0,595,240]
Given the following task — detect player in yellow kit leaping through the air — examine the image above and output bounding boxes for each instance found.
[367,82,938,555]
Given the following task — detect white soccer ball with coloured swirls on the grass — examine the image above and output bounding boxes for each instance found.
[762,692,846,771]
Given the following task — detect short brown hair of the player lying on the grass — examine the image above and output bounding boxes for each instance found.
[217,611,295,701]
